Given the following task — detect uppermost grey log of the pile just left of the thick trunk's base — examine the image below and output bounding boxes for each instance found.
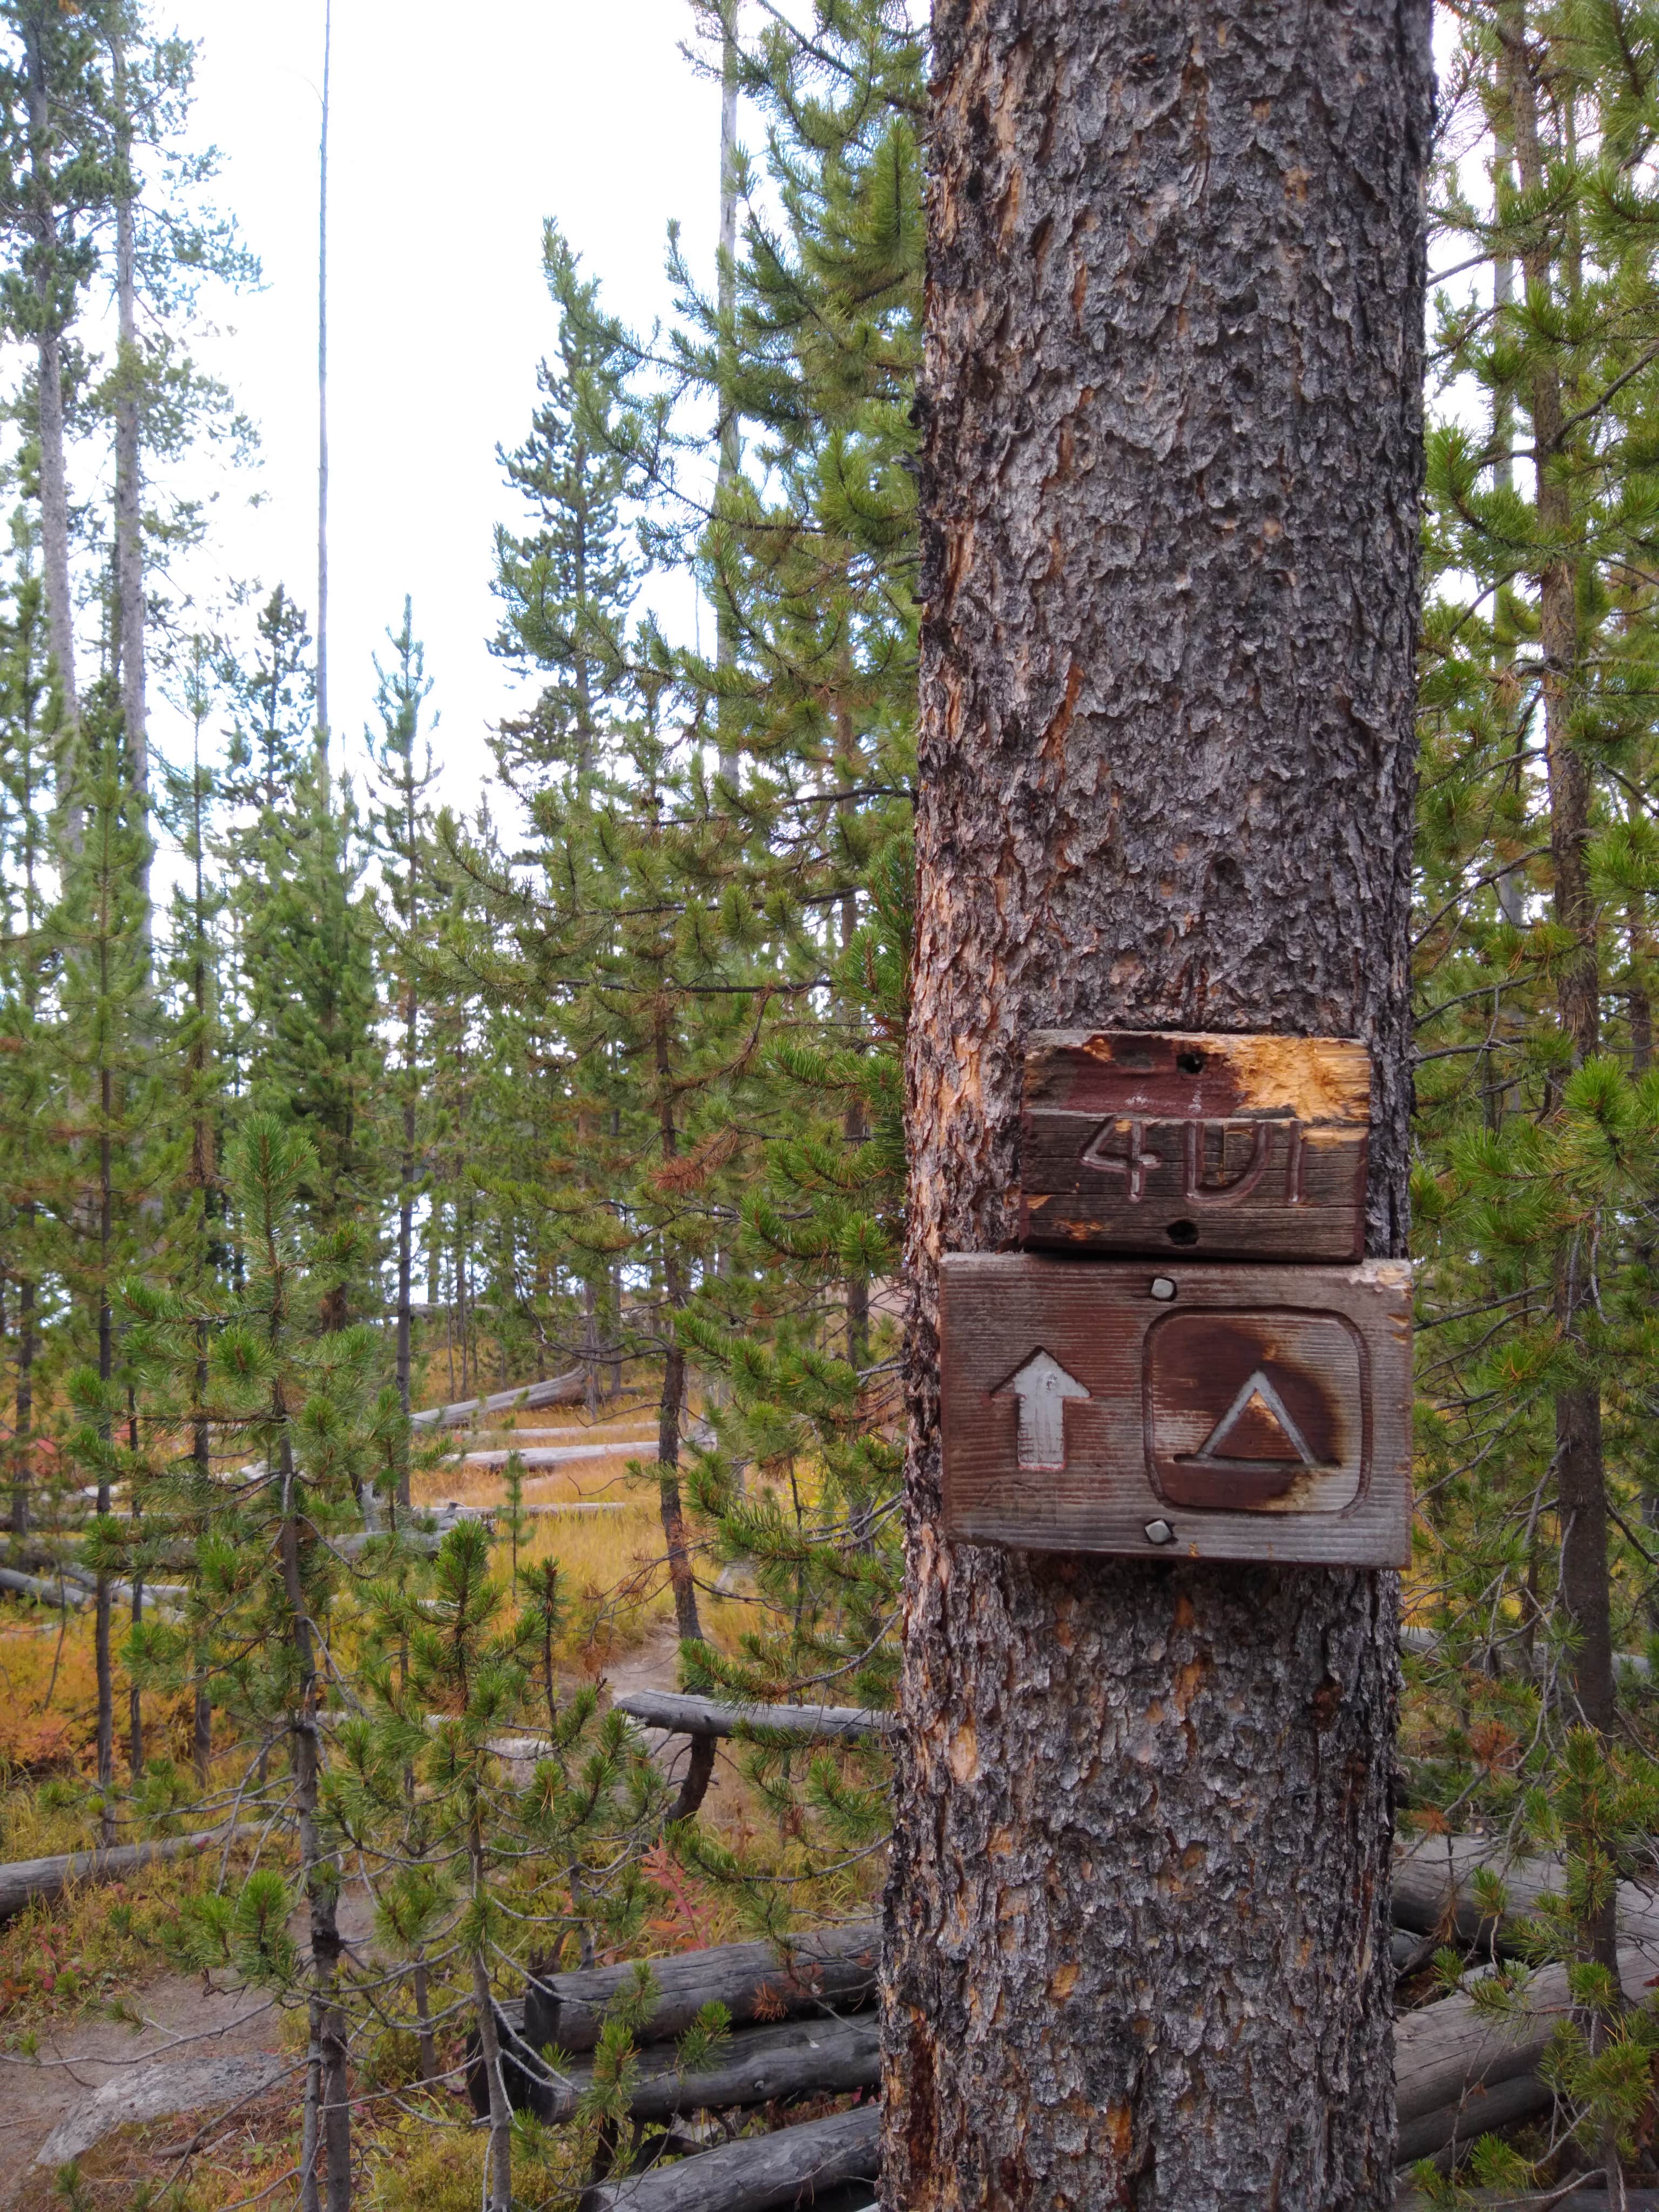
[524,1918,880,2053]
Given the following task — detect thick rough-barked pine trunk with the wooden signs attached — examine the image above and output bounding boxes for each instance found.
[882,0,1431,2212]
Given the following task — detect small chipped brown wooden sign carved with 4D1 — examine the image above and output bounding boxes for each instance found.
[1020,1029,1372,1259]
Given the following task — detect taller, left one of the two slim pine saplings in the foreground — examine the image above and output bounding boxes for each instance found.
[126,1112,396,2212]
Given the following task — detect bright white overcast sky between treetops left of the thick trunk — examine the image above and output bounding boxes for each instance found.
[155,0,719,805]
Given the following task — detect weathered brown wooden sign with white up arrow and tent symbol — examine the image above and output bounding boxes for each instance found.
[940,1252,1411,1566]
